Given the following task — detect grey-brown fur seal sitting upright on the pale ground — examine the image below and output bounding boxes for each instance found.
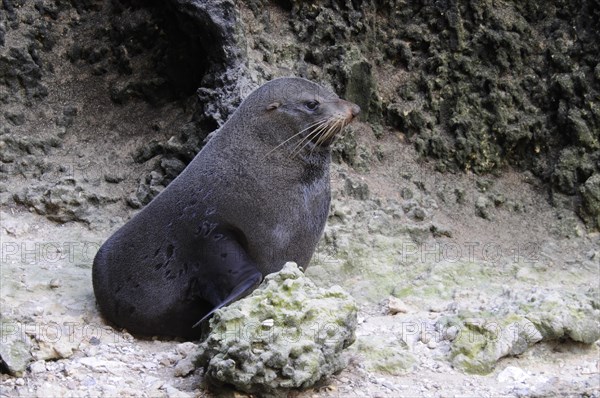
[92,78,360,338]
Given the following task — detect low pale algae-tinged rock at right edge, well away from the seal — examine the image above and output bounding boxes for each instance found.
[436,289,600,374]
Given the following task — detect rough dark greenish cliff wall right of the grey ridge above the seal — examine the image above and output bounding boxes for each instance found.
[242,0,600,229]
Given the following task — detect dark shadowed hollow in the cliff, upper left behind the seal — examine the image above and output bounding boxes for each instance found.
[68,0,230,105]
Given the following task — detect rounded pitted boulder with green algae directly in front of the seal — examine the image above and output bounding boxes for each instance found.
[197,263,357,396]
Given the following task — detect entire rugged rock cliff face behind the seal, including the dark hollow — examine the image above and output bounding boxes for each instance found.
[0,0,600,228]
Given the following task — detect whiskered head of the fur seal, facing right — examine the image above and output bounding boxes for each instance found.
[239,77,360,154]
